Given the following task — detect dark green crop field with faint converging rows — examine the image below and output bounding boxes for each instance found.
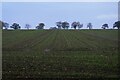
[2,30,119,79]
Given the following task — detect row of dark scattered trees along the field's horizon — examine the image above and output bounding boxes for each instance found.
[0,21,120,30]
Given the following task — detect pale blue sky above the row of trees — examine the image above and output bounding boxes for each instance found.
[0,2,118,29]
